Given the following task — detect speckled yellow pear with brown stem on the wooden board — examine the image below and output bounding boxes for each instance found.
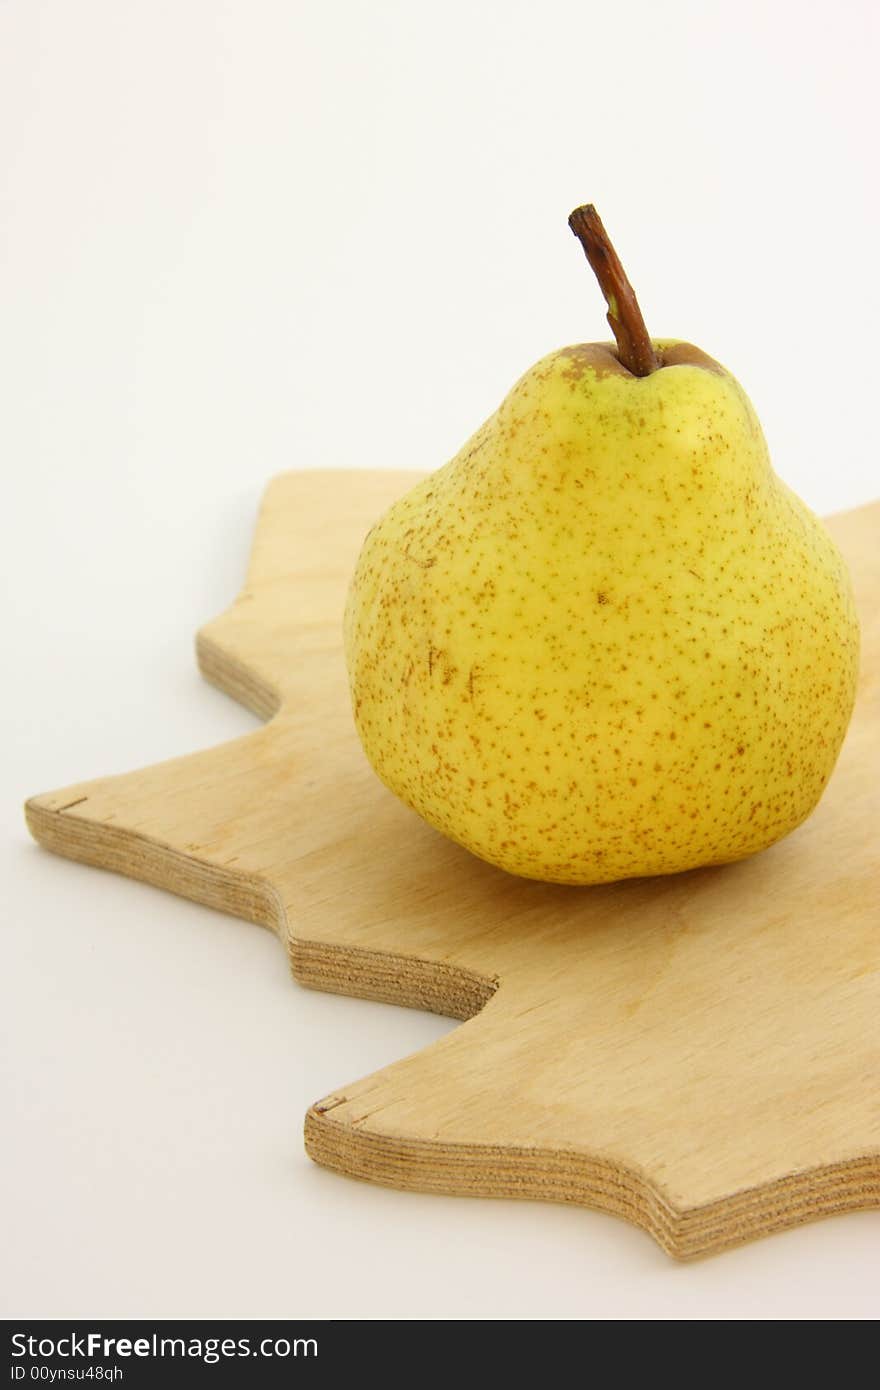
[345,207,858,884]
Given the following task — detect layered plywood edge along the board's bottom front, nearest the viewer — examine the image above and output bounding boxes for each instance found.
[304,1095,880,1261]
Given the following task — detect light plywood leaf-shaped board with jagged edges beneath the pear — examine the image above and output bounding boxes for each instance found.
[26,473,880,1258]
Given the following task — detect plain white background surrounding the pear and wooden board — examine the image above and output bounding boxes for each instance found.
[0,0,880,1319]
